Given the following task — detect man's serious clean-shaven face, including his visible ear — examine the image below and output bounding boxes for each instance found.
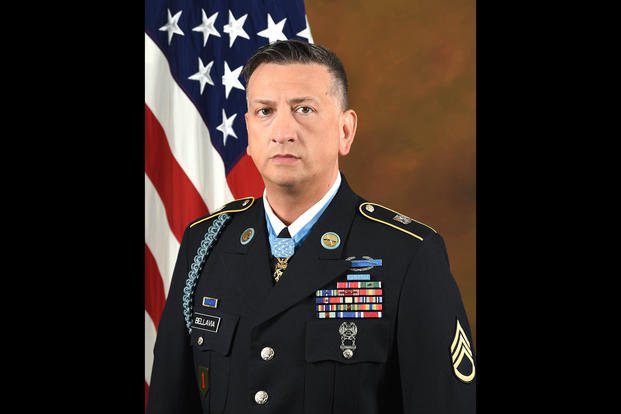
[245,63,356,191]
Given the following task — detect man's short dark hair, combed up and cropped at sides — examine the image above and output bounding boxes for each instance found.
[242,40,348,109]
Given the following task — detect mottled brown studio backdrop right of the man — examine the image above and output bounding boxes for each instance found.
[306,0,476,342]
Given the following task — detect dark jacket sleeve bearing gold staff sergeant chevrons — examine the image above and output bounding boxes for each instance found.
[397,233,476,414]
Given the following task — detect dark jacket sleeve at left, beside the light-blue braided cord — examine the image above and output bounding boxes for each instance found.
[146,229,202,414]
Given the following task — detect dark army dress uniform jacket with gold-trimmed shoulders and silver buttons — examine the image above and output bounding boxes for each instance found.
[147,178,476,414]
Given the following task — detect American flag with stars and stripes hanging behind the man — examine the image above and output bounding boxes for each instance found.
[144,0,313,408]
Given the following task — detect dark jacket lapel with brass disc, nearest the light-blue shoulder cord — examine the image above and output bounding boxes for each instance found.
[221,198,273,314]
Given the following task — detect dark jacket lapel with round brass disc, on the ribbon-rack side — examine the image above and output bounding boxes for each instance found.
[254,176,360,326]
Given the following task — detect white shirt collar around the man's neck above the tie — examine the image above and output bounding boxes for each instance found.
[263,171,341,245]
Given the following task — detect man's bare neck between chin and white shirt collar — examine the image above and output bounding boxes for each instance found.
[265,172,336,226]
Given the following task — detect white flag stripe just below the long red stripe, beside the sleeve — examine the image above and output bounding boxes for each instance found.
[144,174,180,297]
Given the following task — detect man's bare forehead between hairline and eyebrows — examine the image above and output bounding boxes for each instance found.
[248,63,332,94]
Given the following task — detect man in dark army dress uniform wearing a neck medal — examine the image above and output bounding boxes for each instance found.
[147,41,475,414]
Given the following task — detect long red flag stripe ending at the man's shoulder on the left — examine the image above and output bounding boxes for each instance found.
[144,104,209,242]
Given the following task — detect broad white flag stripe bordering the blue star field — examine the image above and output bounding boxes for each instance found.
[144,33,234,212]
